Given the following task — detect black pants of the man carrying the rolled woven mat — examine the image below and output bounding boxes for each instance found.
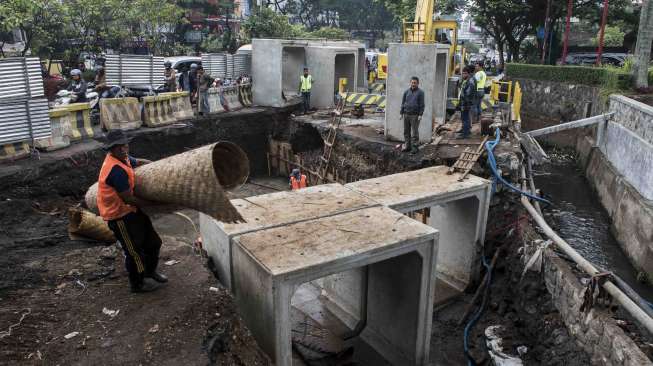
[109,210,161,287]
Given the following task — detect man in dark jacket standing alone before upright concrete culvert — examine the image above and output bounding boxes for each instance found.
[400,76,424,154]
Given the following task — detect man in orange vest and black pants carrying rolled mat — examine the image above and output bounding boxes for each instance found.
[97,130,168,292]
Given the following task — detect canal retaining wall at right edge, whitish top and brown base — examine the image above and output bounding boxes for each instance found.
[576,96,653,279]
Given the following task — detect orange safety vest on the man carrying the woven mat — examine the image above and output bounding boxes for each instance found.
[97,154,136,221]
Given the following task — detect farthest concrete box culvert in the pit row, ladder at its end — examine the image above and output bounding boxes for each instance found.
[345,166,491,291]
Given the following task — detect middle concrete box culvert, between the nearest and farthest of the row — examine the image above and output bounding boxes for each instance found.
[200,183,378,289]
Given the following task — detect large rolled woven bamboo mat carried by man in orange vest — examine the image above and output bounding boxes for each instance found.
[86,141,249,223]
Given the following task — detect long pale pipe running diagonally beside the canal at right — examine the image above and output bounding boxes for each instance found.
[521,184,653,334]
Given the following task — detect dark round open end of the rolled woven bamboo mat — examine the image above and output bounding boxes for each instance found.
[212,141,249,189]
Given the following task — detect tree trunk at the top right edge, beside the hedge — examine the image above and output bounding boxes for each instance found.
[633,0,653,89]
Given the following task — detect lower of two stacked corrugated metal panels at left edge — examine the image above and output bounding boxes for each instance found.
[0,98,51,145]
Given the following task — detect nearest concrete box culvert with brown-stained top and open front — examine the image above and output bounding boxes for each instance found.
[233,207,438,365]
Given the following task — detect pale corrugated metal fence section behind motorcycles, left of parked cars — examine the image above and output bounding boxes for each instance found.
[104,55,165,87]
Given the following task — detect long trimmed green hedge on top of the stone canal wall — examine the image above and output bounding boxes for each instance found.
[506,63,631,90]
